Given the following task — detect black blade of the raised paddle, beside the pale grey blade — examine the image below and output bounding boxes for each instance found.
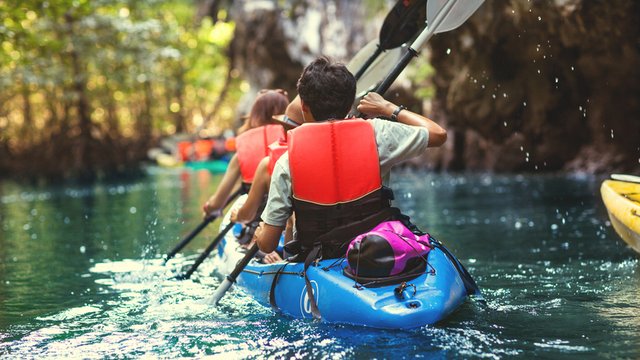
[380,0,427,50]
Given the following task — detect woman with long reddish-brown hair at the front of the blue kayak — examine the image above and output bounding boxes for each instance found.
[202,89,289,217]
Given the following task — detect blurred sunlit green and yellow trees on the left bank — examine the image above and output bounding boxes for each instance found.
[0,0,241,178]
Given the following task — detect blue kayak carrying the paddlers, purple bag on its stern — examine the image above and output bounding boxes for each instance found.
[217,200,467,329]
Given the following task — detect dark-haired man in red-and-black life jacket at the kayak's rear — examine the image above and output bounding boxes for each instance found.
[255,57,447,266]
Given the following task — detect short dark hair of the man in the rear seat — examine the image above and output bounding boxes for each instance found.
[297,56,356,121]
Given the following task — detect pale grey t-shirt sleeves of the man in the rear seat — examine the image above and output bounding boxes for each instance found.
[262,119,429,226]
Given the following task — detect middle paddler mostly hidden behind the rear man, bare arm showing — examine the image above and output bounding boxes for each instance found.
[231,96,302,263]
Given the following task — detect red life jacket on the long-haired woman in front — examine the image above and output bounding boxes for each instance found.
[236,125,284,184]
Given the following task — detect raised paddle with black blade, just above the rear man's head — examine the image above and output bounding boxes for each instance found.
[349,0,427,83]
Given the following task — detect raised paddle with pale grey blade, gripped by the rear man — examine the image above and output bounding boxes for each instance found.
[374,0,484,95]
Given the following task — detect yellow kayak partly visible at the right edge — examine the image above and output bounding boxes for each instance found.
[600,175,640,253]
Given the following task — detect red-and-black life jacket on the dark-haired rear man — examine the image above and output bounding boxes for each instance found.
[287,119,391,261]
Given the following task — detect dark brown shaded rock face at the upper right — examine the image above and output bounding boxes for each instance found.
[429,0,640,172]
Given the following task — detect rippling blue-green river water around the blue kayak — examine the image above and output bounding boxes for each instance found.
[0,168,640,359]
